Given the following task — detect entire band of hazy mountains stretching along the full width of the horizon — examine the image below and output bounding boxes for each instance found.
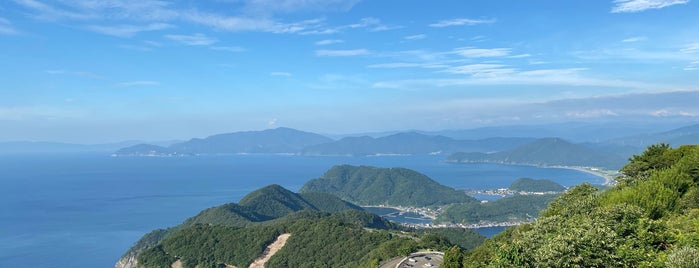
[6,123,699,168]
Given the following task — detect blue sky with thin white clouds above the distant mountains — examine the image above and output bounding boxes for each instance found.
[0,0,699,143]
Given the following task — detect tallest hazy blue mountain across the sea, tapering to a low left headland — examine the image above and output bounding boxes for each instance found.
[116,128,332,155]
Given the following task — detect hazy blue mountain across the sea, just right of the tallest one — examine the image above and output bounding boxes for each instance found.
[303,132,533,156]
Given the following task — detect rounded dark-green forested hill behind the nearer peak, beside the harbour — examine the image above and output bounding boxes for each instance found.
[300,165,477,207]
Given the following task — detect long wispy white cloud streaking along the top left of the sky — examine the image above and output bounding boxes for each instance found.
[10,0,360,37]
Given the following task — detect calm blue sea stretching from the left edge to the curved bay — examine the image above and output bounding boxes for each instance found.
[0,154,604,268]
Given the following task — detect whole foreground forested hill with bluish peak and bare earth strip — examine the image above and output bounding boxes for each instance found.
[132,185,484,268]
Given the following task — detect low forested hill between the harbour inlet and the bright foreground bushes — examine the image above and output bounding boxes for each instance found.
[435,194,557,224]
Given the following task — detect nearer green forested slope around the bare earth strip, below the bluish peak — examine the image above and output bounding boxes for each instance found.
[138,206,484,268]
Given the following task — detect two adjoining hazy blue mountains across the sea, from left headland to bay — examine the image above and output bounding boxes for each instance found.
[114,128,533,156]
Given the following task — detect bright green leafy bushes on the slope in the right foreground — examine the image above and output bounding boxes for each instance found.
[452,144,699,267]
